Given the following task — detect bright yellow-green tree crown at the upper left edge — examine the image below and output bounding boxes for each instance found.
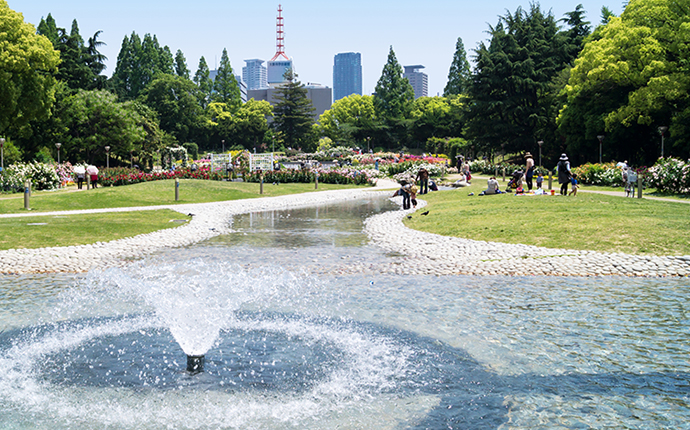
[0,0,60,134]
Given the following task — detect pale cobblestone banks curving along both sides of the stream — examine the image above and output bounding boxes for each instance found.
[0,180,690,276]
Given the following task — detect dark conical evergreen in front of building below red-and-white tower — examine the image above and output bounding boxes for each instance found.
[273,69,316,152]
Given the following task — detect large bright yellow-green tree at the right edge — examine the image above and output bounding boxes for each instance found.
[559,0,690,163]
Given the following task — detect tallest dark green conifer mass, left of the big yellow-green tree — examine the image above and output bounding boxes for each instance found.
[468,4,572,156]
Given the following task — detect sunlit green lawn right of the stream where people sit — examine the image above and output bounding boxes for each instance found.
[405,178,690,255]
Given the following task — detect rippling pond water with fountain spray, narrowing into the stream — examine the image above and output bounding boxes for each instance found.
[0,198,690,429]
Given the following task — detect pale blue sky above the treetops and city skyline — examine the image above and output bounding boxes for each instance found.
[13,0,622,96]
